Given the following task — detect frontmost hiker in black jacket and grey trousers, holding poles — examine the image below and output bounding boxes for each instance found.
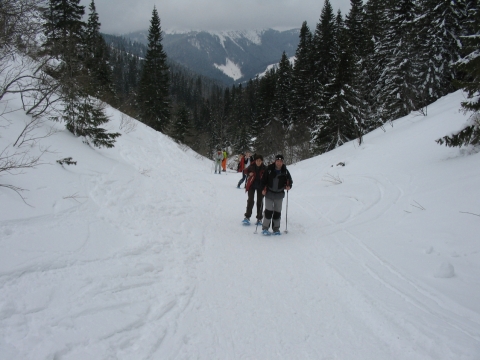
[262,154,293,235]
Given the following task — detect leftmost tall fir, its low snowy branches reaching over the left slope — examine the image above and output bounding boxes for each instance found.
[44,0,120,147]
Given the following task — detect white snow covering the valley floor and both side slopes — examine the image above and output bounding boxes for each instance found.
[0,92,480,360]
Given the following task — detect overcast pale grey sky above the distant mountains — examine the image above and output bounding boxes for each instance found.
[80,0,350,35]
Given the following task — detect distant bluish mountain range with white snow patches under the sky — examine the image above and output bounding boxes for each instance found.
[123,29,300,85]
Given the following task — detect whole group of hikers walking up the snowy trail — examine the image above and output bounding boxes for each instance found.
[214,149,293,236]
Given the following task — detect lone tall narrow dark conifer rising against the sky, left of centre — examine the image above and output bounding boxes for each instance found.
[138,7,170,131]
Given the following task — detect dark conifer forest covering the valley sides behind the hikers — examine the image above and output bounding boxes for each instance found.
[0,0,480,163]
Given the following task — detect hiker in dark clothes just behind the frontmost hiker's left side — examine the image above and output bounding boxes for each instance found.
[243,154,266,225]
